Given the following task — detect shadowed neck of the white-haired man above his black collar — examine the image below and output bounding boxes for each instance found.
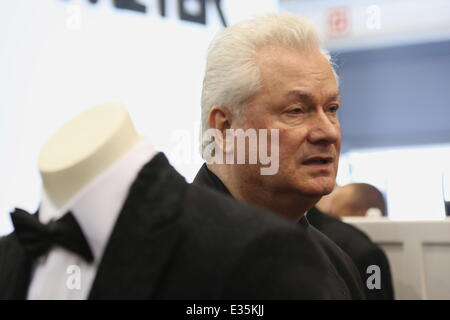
[207,165,319,223]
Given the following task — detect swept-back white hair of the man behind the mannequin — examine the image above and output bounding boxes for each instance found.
[201,13,337,156]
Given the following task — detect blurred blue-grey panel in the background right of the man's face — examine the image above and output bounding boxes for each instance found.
[332,41,450,150]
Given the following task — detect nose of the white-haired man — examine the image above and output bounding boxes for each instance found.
[308,111,341,145]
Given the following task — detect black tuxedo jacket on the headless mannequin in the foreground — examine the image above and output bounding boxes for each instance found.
[0,153,358,299]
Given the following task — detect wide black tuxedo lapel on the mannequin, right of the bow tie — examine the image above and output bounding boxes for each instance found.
[89,153,187,299]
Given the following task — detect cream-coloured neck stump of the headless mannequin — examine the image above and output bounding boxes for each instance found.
[38,103,141,208]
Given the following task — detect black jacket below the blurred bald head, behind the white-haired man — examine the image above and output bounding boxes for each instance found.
[308,207,394,300]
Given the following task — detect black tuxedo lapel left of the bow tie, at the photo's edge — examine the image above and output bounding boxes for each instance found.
[0,233,31,300]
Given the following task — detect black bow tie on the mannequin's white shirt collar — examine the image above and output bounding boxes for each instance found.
[11,209,94,262]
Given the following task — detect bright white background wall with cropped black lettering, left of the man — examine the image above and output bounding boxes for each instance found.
[0,0,278,235]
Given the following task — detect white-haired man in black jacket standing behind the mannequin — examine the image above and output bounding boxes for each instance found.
[194,14,364,299]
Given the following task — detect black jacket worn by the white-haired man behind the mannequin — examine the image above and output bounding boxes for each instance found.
[193,164,365,299]
